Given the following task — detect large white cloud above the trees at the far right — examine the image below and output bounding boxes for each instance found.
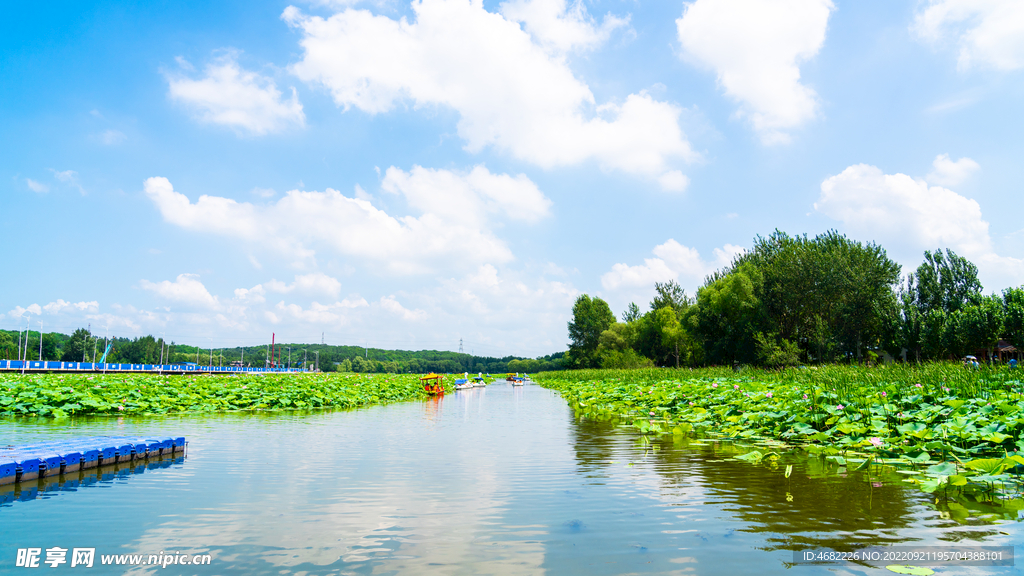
[814,157,1024,289]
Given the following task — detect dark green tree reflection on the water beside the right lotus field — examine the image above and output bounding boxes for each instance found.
[572,412,1020,572]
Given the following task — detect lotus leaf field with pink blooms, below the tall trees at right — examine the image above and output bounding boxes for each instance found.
[537,363,1024,508]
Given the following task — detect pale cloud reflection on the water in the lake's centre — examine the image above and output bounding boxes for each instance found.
[132,389,571,574]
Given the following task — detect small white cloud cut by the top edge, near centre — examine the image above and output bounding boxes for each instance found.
[501,0,630,52]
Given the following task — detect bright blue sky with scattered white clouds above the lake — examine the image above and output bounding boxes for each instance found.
[0,0,1024,356]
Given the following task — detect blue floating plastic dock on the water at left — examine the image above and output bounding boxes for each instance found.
[0,436,186,486]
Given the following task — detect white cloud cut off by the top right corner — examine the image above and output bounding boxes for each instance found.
[910,0,1024,71]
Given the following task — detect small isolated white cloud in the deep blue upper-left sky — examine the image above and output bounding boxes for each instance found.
[167,51,306,135]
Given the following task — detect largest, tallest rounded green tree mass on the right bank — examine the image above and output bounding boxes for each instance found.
[696,231,900,362]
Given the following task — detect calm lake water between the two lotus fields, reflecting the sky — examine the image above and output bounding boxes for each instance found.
[0,383,1024,576]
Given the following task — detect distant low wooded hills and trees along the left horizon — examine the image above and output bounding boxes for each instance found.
[0,328,564,374]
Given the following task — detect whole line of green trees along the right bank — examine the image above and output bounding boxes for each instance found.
[566,231,1024,368]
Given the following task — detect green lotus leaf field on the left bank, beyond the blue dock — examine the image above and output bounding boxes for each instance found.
[0,374,438,418]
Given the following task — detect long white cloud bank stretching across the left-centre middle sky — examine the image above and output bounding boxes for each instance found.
[144,166,550,274]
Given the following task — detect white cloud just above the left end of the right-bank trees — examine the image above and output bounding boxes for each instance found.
[601,239,743,290]
